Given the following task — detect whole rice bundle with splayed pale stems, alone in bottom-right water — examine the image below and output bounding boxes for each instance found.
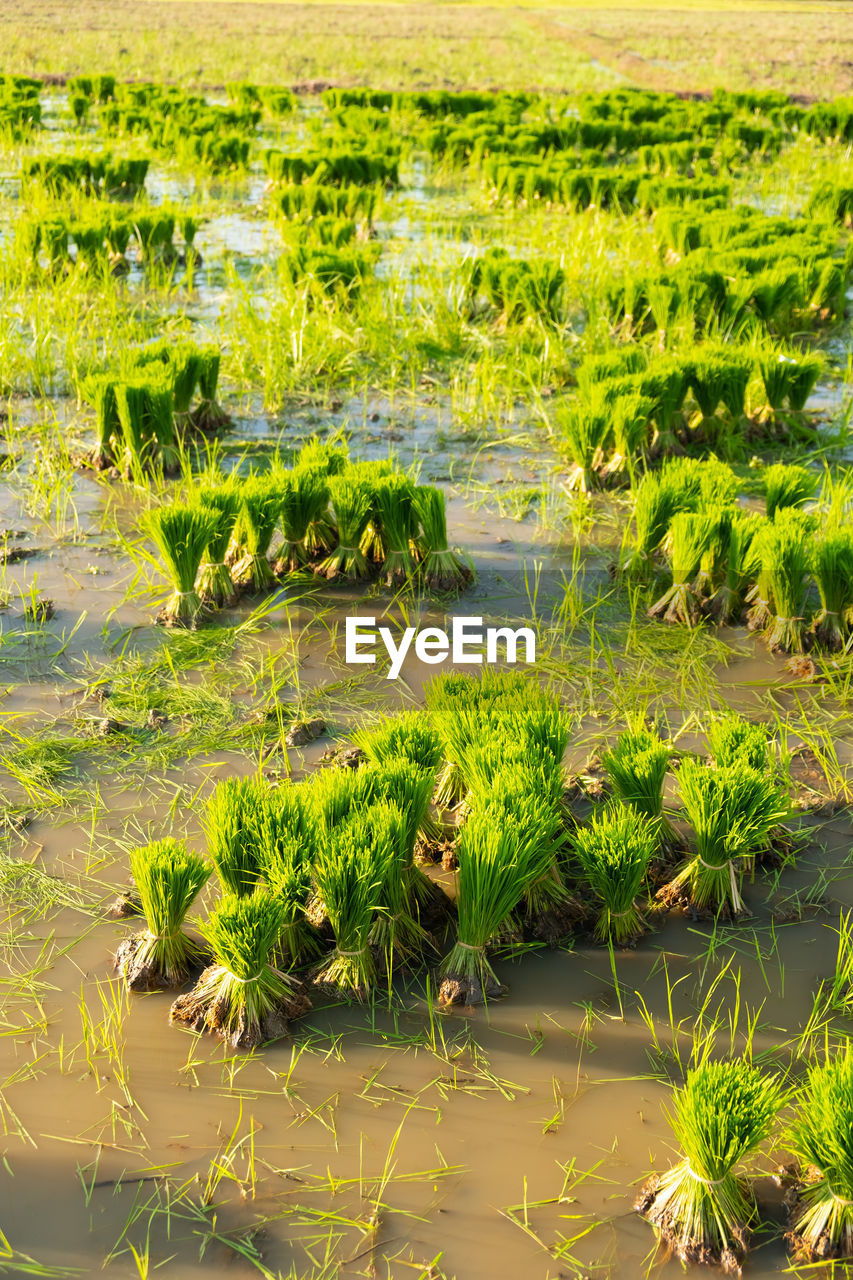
[637,1059,784,1274]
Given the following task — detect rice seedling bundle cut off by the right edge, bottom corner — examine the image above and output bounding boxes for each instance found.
[785,1039,853,1262]
